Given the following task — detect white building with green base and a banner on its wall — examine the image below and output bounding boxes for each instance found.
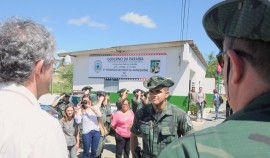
[59,40,209,108]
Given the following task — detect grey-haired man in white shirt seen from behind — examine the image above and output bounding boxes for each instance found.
[0,17,68,158]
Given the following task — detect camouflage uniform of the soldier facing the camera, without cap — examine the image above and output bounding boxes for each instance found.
[131,103,193,157]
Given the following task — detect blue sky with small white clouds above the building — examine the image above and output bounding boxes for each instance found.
[0,0,222,60]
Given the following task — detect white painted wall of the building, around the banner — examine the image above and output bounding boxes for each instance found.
[71,44,206,96]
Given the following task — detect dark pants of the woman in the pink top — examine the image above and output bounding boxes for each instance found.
[115,132,130,158]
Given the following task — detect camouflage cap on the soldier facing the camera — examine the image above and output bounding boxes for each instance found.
[143,76,174,89]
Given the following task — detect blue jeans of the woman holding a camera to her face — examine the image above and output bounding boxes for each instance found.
[82,130,100,158]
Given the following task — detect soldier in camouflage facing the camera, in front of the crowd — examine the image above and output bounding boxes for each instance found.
[130,76,193,158]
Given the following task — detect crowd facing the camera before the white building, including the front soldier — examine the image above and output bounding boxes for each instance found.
[52,76,193,158]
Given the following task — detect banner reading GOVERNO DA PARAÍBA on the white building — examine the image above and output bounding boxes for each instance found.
[89,53,167,79]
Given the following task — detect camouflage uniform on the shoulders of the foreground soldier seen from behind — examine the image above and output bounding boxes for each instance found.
[160,93,270,158]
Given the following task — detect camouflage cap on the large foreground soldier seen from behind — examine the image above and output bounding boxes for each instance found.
[203,0,270,50]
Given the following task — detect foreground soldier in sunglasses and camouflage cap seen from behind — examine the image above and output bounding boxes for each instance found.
[160,0,270,158]
